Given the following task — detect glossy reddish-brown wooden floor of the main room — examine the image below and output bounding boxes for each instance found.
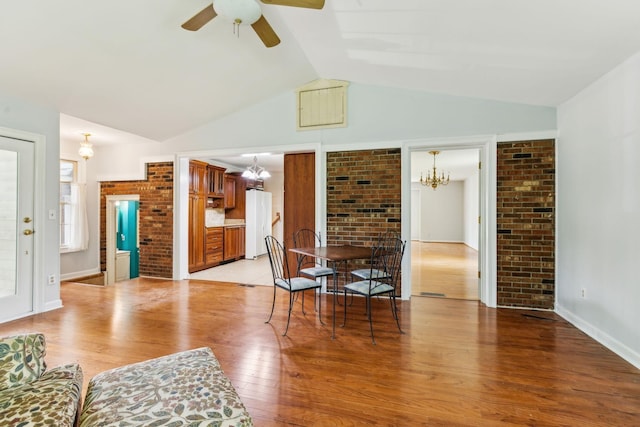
[0,279,640,426]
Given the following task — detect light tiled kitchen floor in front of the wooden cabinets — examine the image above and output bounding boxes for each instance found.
[191,255,273,286]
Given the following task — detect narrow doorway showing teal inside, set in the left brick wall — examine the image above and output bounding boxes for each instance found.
[105,194,140,285]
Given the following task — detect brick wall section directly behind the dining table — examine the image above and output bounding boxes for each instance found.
[327,148,401,246]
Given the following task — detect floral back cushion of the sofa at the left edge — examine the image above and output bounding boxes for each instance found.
[0,333,47,390]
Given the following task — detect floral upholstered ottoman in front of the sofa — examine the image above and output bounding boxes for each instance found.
[80,347,253,427]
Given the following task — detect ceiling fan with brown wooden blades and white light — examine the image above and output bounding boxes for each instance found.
[182,0,324,47]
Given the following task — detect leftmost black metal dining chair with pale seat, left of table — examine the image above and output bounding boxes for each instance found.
[264,236,323,336]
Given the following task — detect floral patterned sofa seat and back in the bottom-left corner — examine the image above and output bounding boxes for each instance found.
[0,333,82,427]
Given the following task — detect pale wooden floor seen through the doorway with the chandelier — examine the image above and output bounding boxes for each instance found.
[411,241,479,300]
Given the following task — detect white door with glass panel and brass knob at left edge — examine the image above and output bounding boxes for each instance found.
[0,136,34,319]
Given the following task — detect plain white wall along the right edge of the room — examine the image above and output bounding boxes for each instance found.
[556,53,640,368]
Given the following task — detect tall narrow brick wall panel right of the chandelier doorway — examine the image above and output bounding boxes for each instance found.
[497,140,555,309]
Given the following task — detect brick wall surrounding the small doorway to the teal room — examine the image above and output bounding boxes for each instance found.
[100,162,173,278]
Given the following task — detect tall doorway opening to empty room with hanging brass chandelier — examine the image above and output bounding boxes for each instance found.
[411,148,480,300]
